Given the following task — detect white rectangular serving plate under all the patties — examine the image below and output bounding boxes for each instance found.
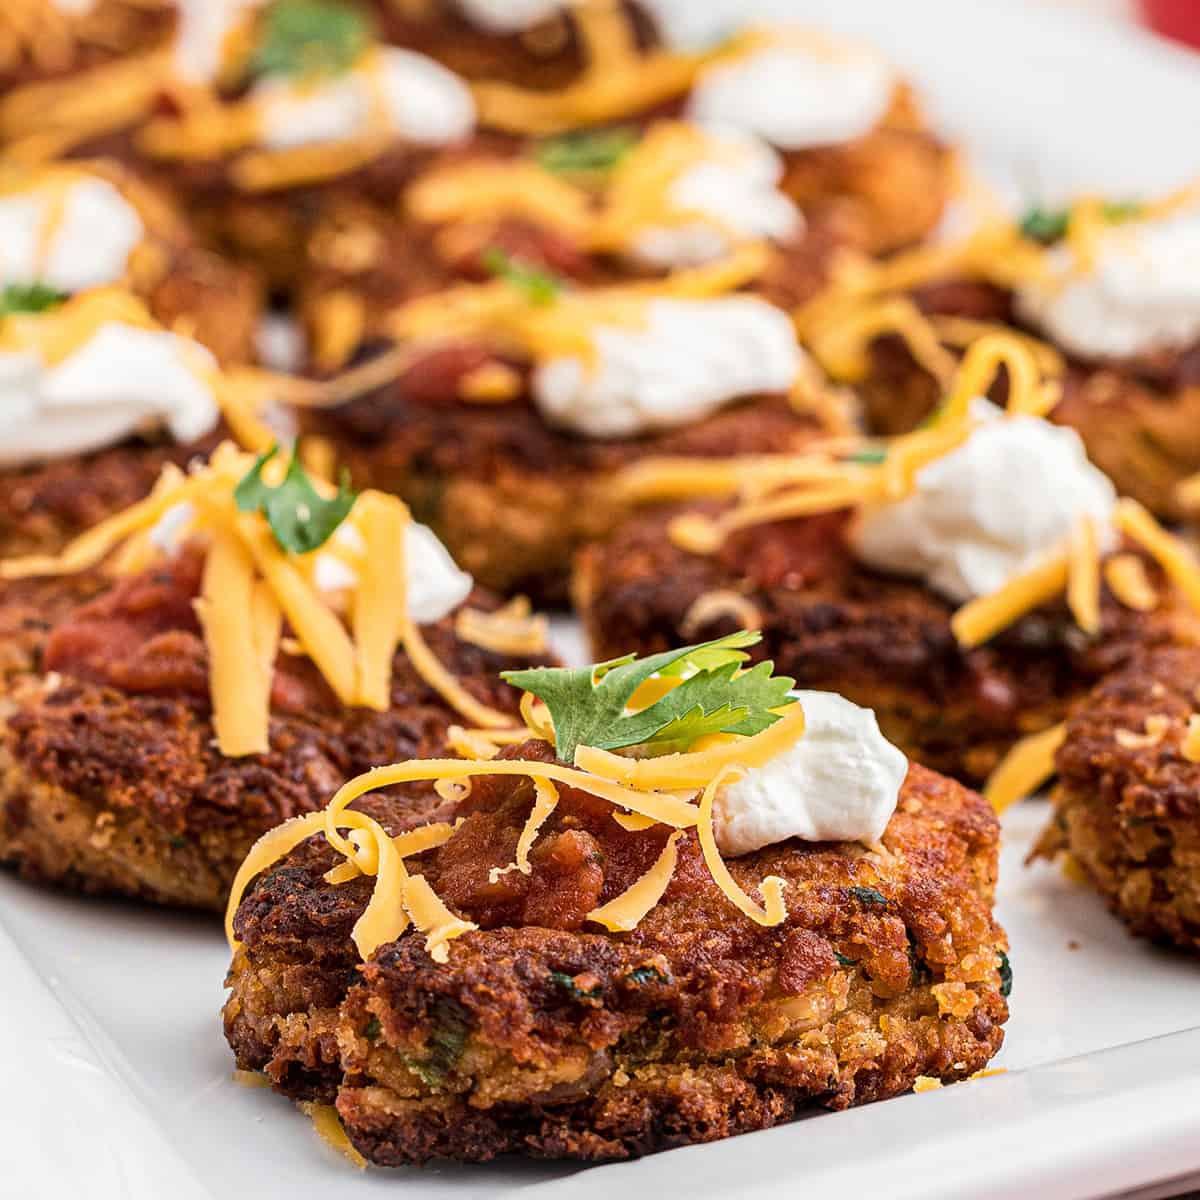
[0,0,1200,1200]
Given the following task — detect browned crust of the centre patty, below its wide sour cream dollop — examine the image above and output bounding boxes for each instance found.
[308,391,835,602]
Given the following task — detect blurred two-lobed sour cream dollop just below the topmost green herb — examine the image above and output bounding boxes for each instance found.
[251,47,475,150]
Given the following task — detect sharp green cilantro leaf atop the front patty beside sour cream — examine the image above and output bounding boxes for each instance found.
[503,630,796,762]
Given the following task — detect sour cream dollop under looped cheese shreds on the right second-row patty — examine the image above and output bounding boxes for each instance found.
[852,401,1117,604]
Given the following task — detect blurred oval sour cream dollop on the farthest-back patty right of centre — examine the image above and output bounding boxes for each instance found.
[688,34,896,150]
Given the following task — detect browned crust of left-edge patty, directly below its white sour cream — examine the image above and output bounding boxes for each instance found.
[0,432,220,558]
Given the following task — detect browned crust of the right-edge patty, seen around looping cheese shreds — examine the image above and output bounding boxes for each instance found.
[859,280,1200,521]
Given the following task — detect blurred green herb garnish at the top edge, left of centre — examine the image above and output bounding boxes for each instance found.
[250,0,372,78]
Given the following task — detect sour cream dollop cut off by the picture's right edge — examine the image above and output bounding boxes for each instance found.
[1016,209,1200,358]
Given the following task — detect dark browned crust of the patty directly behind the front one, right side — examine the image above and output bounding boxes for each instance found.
[574,512,1200,780]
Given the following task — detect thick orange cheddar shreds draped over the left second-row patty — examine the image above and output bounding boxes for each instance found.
[0,443,516,757]
